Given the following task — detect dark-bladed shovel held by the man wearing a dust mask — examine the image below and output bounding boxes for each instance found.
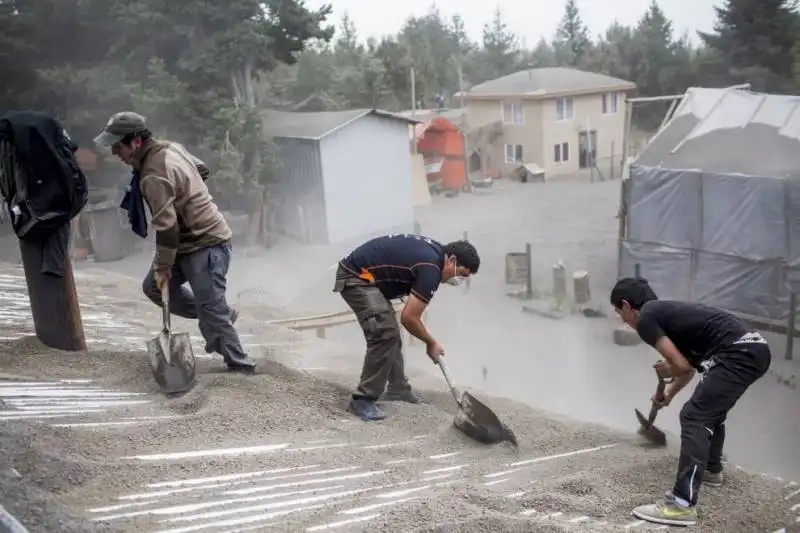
[436,357,517,448]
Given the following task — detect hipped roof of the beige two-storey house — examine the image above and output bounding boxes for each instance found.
[465,67,636,98]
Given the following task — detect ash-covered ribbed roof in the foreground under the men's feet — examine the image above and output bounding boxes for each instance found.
[0,264,800,533]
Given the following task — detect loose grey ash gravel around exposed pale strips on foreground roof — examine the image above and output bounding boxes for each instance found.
[0,330,788,533]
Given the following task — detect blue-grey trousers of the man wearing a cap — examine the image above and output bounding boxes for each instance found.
[142,242,254,366]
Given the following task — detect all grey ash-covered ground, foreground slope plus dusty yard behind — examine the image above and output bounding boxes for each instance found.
[0,177,800,533]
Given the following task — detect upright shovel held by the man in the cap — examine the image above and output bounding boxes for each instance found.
[147,284,195,395]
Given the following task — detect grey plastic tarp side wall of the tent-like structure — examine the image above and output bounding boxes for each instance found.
[622,166,800,319]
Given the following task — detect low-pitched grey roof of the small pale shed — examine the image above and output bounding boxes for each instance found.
[262,109,419,141]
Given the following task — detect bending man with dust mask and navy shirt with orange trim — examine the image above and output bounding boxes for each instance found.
[333,233,481,421]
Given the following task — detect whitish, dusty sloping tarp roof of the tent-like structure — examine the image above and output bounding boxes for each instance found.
[632,88,800,178]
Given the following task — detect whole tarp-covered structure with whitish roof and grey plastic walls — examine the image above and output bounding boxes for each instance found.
[619,89,800,321]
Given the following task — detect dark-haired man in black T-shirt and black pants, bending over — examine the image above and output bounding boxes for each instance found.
[611,278,772,526]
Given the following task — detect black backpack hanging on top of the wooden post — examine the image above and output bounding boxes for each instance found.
[0,111,89,239]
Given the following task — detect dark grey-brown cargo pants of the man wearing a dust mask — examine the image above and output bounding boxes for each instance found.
[333,266,411,400]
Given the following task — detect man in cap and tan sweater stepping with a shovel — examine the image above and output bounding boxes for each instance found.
[95,112,255,374]
